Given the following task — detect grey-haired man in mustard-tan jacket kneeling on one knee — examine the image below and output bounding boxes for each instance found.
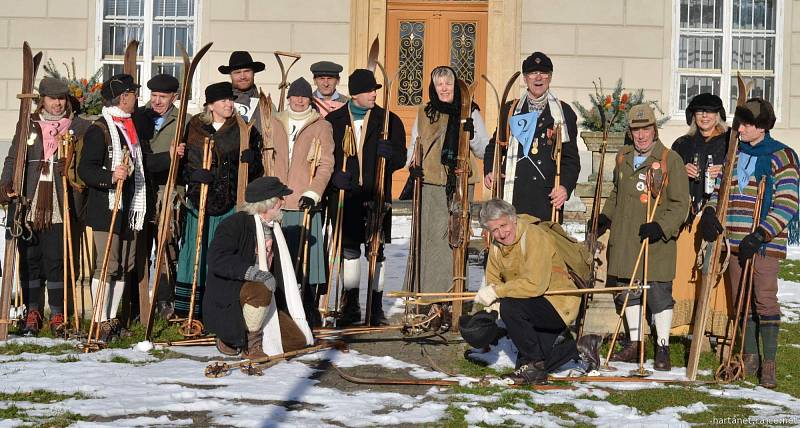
[475,199,599,384]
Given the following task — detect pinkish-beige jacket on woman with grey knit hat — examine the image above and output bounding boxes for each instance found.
[270,113,333,210]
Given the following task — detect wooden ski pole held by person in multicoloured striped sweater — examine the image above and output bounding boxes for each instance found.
[714,177,766,382]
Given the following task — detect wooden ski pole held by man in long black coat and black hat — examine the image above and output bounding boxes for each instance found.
[319,125,356,322]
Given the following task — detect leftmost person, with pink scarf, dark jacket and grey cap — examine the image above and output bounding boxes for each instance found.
[0,77,89,336]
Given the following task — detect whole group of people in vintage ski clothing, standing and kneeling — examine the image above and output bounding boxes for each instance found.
[0,46,798,387]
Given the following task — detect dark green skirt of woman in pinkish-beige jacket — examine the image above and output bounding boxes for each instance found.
[281,210,326,284]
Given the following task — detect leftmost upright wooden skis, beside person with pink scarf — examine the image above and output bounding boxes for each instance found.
[0,42,42,340]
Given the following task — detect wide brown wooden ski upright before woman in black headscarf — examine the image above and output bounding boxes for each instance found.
[448,79,477,332]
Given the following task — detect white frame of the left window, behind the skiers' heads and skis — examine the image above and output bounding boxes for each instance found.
[92,0,203,108]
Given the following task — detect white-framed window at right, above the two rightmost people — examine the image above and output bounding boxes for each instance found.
[673,0,783,116]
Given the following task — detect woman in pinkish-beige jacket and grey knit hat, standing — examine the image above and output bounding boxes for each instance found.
[270,77,333,327]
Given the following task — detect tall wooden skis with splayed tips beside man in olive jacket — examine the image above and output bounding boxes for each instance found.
[144,43,212,340]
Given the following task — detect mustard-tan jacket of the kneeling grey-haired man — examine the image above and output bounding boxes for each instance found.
[486,214,581,325]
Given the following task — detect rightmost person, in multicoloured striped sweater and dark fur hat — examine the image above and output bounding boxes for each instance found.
[700,98,800,388]
